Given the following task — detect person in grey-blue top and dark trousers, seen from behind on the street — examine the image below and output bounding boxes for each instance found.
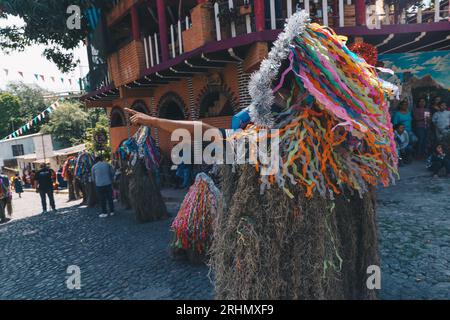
[92,156,114,218]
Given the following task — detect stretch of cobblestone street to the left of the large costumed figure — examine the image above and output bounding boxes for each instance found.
[0,193,213,299]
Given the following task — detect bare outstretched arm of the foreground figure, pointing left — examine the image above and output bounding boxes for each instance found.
[125,108,216,134]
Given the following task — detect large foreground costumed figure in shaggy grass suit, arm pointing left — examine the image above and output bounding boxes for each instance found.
[127,11,397,299]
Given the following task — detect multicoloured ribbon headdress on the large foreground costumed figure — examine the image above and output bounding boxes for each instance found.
[241,23,397,198]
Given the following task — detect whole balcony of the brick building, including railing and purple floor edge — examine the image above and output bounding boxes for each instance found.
[85,0,450,100]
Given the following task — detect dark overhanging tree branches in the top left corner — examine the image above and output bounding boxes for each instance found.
[0,0,112,72]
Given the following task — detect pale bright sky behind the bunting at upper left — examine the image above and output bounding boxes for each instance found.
[0,16,89,92]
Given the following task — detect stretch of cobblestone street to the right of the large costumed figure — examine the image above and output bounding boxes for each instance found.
[378,163,450,299]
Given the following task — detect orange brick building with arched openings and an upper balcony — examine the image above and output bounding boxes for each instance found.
[83,0,450,152]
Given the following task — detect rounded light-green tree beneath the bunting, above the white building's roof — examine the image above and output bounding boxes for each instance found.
[41,101,89,147]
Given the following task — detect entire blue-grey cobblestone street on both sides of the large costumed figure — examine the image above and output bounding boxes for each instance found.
[0,164,450,299]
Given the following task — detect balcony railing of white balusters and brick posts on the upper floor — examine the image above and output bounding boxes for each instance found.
[96,0,449,89]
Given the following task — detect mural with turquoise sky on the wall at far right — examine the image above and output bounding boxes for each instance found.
[378,51,450,106]
